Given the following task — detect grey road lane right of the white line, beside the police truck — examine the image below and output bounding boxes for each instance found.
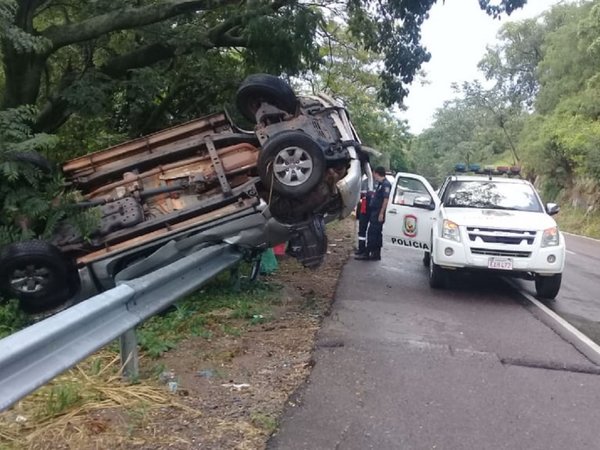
[519,235,600,344]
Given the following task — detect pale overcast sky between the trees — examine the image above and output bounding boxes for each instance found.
[400,0,559,134]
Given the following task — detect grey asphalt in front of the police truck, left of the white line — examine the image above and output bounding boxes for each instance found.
[269,243,600,450]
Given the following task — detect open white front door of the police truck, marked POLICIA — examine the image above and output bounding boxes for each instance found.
[383,172,440,252]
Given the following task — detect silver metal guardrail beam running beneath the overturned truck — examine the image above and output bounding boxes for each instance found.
[0,244,242,410]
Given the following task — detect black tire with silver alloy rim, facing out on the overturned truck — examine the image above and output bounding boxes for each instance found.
[258,131,325,198]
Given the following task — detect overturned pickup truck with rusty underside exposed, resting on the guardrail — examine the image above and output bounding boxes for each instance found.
[0,74,371,310]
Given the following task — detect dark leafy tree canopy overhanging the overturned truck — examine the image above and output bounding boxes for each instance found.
[0,0,525,135]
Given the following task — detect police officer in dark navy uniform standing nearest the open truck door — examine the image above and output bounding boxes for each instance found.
[356,166,392,261]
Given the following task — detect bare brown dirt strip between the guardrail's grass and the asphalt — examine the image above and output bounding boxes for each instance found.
[135,220,354,449]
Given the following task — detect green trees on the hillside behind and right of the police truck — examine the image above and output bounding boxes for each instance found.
[410,0,600,234]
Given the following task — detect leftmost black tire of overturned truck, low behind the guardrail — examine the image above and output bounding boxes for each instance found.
[0,240,76,312]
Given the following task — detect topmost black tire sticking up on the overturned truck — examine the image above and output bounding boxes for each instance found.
[235,73,298,123]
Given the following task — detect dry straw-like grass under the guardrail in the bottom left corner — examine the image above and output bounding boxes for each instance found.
[0,351,198,449]
